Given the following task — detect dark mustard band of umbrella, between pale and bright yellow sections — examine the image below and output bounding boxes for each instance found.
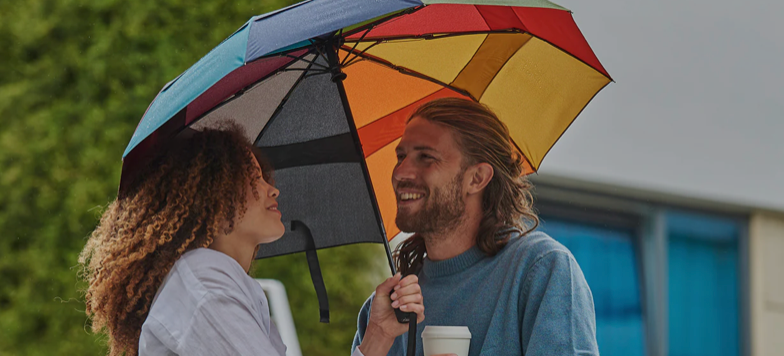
[452,33,531,98]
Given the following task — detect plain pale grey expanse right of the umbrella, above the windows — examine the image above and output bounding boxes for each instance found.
[540,0,784,211]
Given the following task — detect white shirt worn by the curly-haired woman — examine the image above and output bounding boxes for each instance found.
[139,248,363,356]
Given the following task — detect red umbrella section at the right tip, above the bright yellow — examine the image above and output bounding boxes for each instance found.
[513,7,610,78]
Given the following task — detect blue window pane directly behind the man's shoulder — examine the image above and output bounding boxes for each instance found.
[542,217,645,356]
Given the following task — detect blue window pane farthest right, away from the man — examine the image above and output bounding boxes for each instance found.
[667,213,740,356]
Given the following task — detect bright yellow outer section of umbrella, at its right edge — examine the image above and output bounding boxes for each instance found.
[479,38,609,169]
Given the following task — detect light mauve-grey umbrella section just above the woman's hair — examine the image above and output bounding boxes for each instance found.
[191,55,315,143]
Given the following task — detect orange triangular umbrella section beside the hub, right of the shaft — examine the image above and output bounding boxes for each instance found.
[341,54,443,128]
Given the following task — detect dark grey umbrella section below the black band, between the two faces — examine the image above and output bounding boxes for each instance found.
[257,163,384,258]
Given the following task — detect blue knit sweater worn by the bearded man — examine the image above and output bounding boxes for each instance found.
[352,231,599,356]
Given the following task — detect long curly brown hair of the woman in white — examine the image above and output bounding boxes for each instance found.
[79,123,268,355]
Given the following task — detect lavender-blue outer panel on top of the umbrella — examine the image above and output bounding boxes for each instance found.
[246,0,422,62]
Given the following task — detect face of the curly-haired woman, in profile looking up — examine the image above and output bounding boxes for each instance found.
[235,160,286,244]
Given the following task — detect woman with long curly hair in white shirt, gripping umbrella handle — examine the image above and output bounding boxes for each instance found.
[79,125,424,356]
